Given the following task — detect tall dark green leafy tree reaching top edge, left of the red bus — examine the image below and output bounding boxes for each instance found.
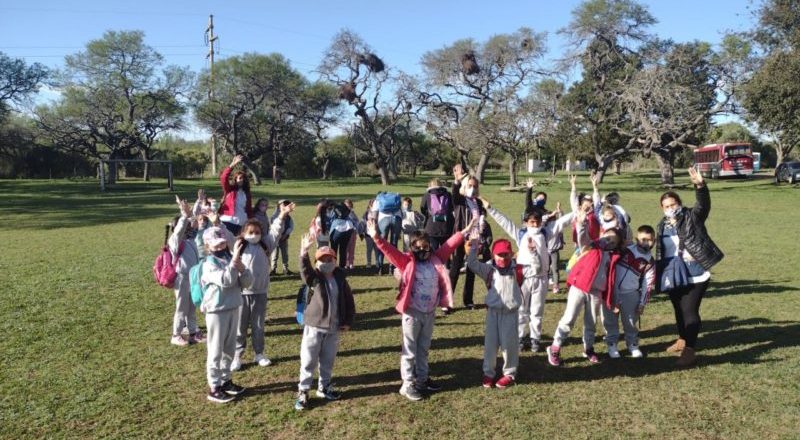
[561,0,656,181]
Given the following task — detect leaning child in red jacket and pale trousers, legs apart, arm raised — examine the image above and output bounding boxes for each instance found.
[547,211,622,367]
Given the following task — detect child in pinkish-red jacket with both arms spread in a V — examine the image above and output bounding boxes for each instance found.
[367,218,477,401]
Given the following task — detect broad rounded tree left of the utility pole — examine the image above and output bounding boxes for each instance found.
[36,31,192,183]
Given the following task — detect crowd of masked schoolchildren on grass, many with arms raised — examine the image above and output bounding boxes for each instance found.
[161,159,655,410]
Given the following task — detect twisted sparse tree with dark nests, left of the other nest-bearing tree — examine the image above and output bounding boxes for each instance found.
[318,29,418,185]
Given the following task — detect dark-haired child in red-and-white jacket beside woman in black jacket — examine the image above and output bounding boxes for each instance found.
[603,225,656,359]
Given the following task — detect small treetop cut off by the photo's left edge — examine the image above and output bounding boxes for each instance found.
[0,52,50,122]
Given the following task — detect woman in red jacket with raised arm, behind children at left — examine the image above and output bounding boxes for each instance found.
[219,154,253,235]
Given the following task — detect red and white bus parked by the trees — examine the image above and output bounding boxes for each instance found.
[694,142,753,179]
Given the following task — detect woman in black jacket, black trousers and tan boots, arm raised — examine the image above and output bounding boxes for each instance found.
[656,168,724,367]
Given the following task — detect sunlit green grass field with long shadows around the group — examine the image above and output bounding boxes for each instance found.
[0,172,800,439]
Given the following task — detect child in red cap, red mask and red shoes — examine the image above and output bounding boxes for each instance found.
[467,235,522,388]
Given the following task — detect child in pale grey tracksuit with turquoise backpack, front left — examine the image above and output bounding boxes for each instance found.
[198,226,253,403]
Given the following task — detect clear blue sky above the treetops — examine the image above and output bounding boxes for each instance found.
[0,0,752,136]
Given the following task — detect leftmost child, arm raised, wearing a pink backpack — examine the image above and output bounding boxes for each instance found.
[165,196,206,347]
